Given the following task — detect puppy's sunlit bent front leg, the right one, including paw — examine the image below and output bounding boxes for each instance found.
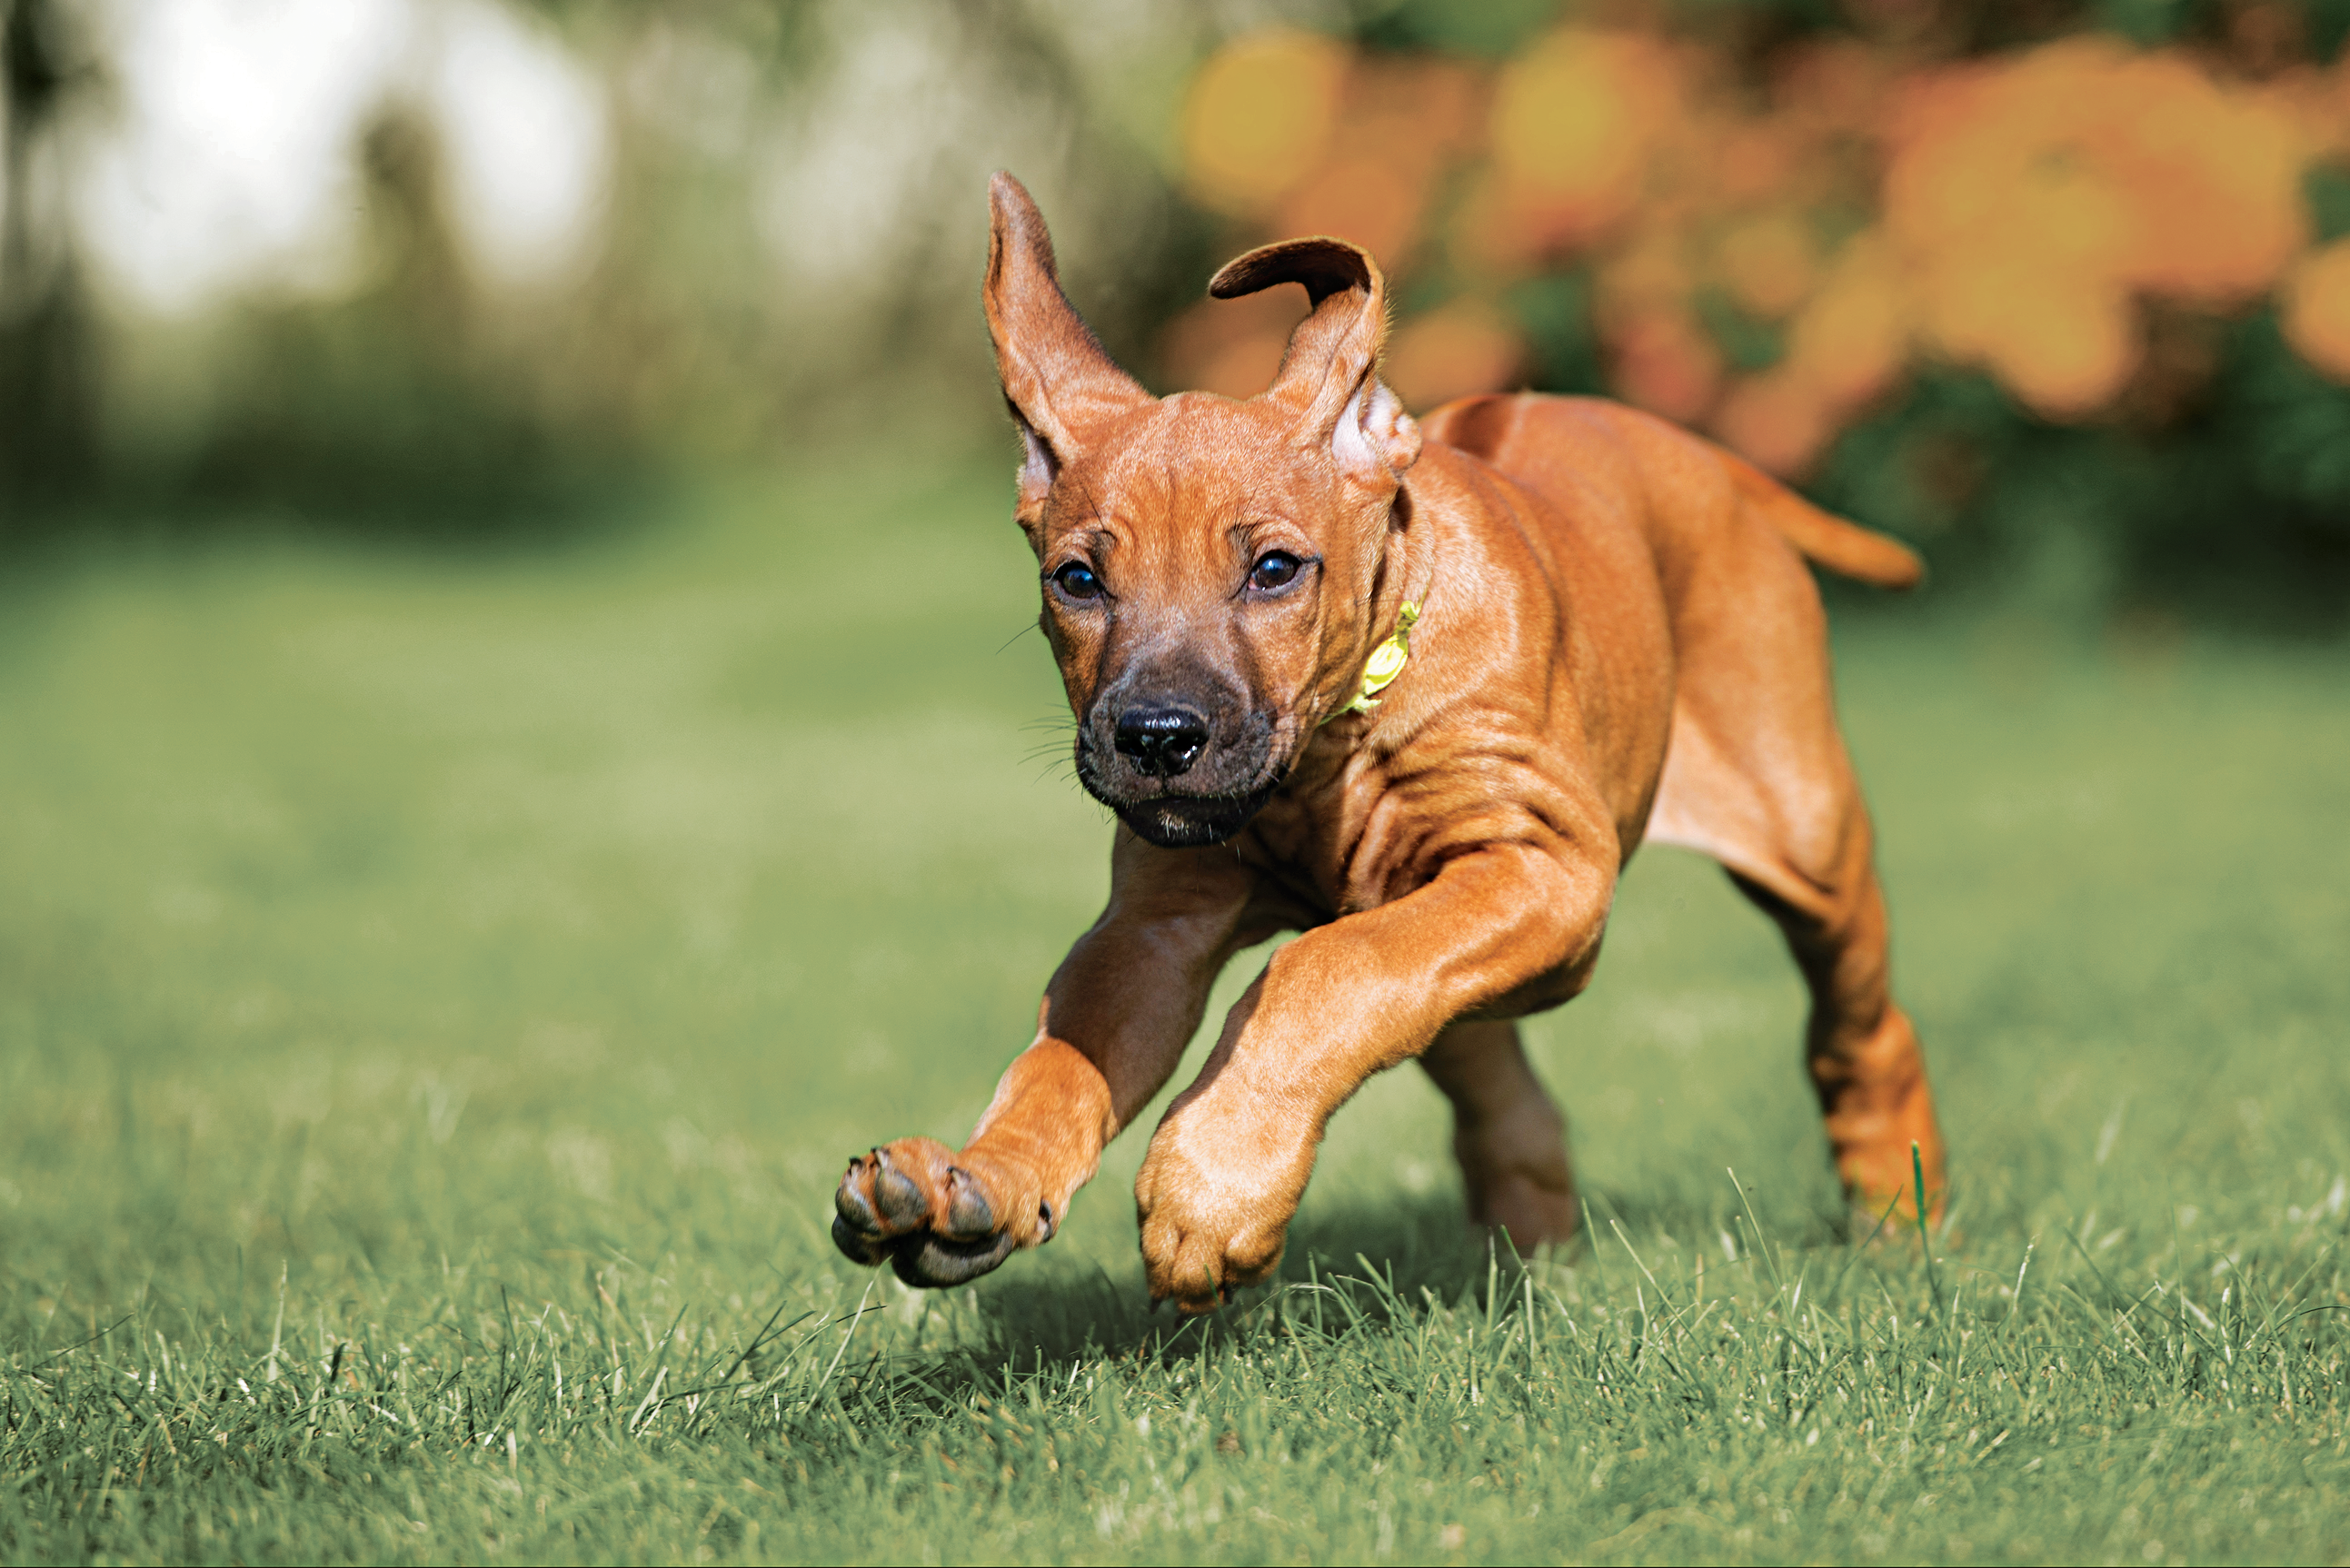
[1135,844,1615,1312]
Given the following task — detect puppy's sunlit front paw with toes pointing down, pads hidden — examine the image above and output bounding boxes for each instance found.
[1135,1124,1314,1315]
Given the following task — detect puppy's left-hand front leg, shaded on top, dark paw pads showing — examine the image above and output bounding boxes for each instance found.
[831,828,1255,1285]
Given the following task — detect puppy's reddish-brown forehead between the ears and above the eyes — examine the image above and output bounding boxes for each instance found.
[1053,392,1328,533]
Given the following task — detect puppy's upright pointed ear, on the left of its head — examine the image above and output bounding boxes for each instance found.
[982,172,1151,521]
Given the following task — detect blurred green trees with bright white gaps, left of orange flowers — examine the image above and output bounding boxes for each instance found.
[0,0,1231,541]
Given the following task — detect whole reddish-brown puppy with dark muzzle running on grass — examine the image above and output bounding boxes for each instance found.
[831,174,1944,1312]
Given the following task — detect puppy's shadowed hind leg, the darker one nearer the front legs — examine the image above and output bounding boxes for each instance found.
[1419,1020,1577,1255]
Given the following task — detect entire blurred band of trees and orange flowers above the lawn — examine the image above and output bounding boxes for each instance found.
[14,0,2350,625]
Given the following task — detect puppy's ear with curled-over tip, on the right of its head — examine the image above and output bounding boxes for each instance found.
[1208,237,1419,489]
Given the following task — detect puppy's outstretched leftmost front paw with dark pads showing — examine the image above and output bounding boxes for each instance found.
[831,1137,1053,1288]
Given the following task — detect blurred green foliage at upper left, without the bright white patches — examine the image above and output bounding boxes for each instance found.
[0,0,1206,551]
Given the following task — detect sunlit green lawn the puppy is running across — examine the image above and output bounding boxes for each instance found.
[0,456,2350,1563]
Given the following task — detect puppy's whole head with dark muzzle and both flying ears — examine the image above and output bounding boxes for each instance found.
[985,174,1419,847]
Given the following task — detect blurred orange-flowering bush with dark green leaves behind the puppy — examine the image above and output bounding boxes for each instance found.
[1166,0,2350,625]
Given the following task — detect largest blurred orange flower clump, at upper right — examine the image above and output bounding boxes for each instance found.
[1882,37,2307,419]
